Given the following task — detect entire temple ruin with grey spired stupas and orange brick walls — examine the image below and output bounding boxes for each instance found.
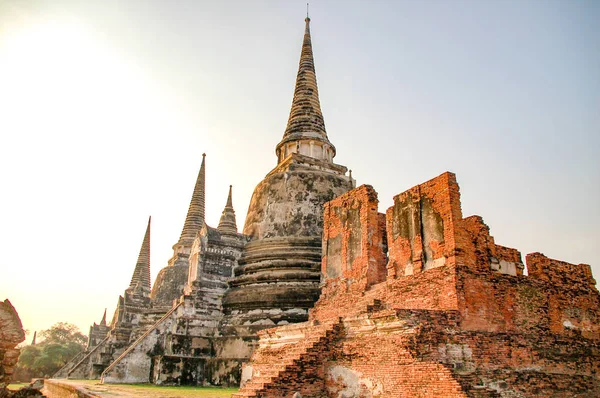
[51,14,600,398]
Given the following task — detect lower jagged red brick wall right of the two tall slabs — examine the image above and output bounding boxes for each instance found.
[458,216,600,338]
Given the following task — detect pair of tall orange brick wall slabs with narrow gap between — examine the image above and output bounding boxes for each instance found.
[311,177,464,320]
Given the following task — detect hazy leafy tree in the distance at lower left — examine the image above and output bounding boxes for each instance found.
[15,322,87,381]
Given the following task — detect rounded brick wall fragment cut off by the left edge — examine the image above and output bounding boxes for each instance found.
[0,299,25,388]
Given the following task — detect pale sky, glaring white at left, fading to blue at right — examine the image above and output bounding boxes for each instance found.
[0,0,600,340]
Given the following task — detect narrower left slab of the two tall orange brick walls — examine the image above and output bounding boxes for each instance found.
[310,185,387,320]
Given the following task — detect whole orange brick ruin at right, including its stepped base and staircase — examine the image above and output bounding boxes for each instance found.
[235,173,600,397]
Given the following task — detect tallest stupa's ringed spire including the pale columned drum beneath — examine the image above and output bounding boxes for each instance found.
[276,14,335,162]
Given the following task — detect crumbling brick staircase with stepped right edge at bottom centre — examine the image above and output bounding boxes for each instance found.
[232,320,343,398]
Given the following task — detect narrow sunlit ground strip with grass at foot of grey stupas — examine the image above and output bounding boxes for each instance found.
[52,380,238,398]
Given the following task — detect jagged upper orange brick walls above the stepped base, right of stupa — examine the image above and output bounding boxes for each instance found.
[312,173,600,338]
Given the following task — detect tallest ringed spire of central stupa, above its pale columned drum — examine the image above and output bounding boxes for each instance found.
[276,15,335,161]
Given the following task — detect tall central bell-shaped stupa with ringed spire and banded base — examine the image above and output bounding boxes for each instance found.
[223,17,353,334]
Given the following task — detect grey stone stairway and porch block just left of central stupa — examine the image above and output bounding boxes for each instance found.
[102,218,250,385]
